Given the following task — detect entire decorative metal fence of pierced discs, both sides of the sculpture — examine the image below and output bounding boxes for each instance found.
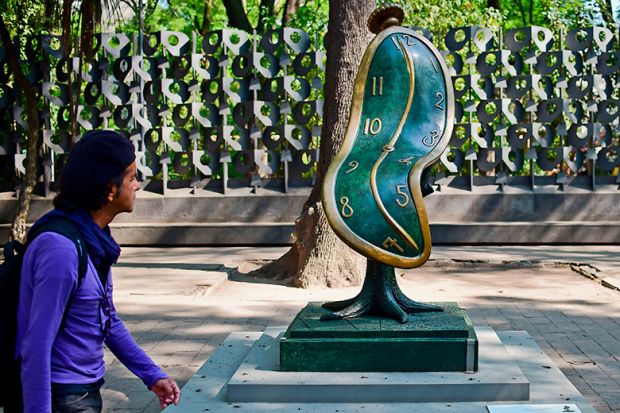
[0,27,620,193]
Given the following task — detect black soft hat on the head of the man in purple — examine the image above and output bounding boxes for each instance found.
[60,130,136,198]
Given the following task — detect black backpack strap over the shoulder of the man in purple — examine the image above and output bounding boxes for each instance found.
[26,217,88,328]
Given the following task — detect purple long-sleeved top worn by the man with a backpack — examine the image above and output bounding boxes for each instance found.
[16,232,168,413]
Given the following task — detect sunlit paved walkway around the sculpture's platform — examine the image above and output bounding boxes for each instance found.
[92,246,620,413]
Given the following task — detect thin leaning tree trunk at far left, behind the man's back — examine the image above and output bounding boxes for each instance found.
[0,14,41,242]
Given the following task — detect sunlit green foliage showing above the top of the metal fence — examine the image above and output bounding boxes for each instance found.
[0,0,620,38]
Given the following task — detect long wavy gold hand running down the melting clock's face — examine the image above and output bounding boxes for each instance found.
[370,37,420,251]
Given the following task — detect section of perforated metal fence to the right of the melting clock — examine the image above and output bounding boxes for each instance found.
[441,27,620,189]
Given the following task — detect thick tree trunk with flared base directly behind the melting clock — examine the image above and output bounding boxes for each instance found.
[252,0,374,288]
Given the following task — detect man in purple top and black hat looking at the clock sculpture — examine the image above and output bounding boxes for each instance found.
[16,130,180,413]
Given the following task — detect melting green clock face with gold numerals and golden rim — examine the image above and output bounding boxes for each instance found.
[323,27,454,268]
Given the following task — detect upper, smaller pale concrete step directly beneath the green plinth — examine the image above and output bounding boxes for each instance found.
[226,328,530,403]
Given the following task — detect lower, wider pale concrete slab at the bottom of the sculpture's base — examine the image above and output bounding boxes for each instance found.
[166,327,596,413]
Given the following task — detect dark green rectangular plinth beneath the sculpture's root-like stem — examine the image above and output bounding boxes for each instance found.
[280,302,478,372]
